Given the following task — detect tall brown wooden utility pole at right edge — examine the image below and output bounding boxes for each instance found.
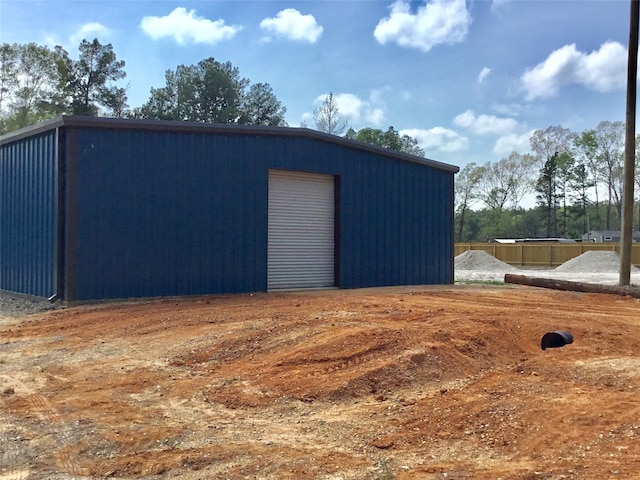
[620,0,640,286]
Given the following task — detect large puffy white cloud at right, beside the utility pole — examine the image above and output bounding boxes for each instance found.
[521,42,627,100]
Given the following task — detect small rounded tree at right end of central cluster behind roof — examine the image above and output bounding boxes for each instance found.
[238,83,287,127]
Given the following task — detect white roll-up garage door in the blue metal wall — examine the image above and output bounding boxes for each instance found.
[267,170,335,290]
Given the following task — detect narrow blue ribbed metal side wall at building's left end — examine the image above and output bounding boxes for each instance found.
[0,130,57,297]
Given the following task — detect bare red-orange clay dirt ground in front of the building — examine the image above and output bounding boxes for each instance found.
[0,285,640,480]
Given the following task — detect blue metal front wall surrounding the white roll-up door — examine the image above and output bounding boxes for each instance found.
[67,127,453,300]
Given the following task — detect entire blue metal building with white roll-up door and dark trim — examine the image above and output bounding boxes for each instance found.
[0,116,458,302]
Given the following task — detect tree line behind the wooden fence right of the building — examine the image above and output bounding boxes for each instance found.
[454,121,640,241]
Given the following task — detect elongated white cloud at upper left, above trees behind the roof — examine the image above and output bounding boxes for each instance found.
[140,7,242,45]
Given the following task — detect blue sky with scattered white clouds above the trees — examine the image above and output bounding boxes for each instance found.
[0,0,629,171]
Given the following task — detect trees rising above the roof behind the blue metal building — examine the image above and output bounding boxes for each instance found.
[0,38,424,160]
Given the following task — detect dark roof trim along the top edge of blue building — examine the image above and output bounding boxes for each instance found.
[0,115,460,173]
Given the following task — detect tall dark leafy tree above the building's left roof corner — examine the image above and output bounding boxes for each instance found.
[56,38,127,116]
